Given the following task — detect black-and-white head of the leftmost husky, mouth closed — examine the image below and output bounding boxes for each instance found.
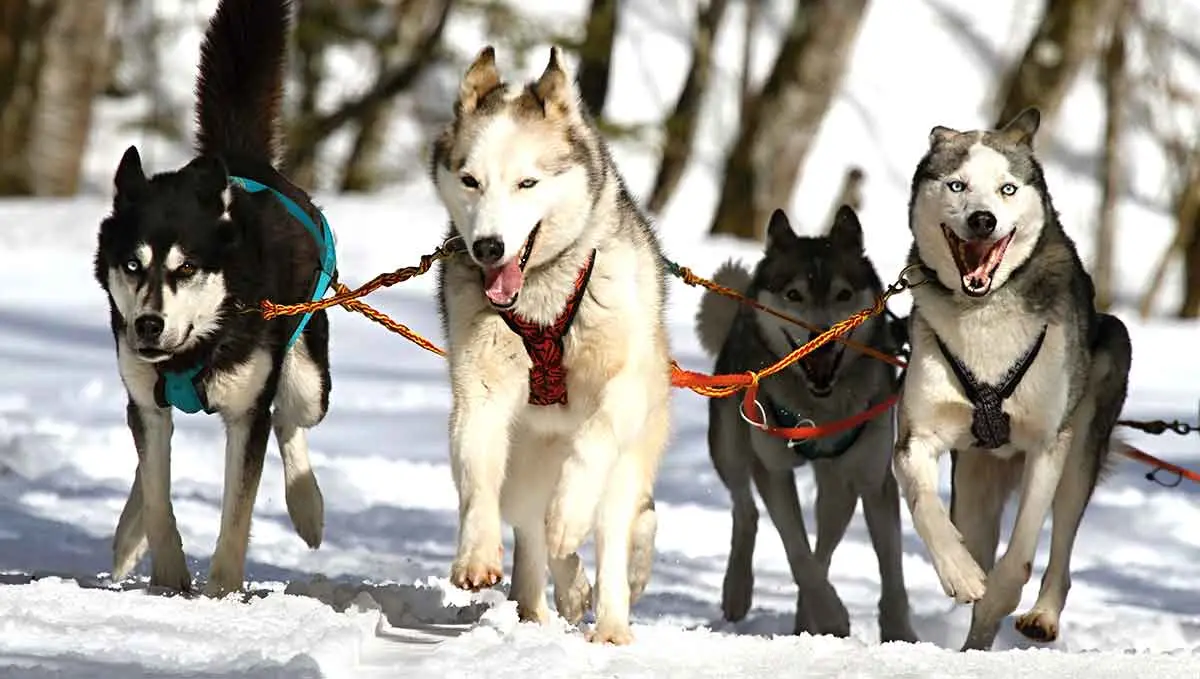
[97,149,238,362]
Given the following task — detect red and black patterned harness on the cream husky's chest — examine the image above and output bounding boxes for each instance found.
[500,250,596,405]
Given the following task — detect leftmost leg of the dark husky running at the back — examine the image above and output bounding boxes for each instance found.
[708,398,758,623]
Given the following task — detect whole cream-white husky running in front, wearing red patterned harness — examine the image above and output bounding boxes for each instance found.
[431,47,671,643]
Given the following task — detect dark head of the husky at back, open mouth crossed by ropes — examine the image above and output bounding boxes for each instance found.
[756,206,880,398]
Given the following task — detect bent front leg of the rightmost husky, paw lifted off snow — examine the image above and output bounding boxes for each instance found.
[893,427,985,603]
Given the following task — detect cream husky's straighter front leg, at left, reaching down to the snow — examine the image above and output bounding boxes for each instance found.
[450,390,515,590]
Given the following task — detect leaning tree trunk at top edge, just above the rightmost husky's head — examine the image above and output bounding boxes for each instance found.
[995,0,1113,127]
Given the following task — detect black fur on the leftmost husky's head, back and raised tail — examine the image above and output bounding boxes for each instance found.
[95,0,330,415]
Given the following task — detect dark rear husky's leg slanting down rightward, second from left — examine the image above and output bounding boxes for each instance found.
[754,462,850,637]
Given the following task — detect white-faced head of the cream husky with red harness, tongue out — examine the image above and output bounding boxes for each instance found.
[433,47,598,310]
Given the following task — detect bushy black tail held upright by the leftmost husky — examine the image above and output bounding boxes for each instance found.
[196,0,292,164]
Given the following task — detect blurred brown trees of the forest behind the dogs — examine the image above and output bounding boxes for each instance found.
[0,0,1200,318]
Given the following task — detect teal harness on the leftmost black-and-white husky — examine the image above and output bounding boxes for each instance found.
[155,176,337,414]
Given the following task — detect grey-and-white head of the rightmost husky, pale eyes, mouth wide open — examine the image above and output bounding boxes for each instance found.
[911,110,1045,298]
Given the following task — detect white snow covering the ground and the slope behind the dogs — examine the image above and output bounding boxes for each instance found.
[0,0,1200,679]
